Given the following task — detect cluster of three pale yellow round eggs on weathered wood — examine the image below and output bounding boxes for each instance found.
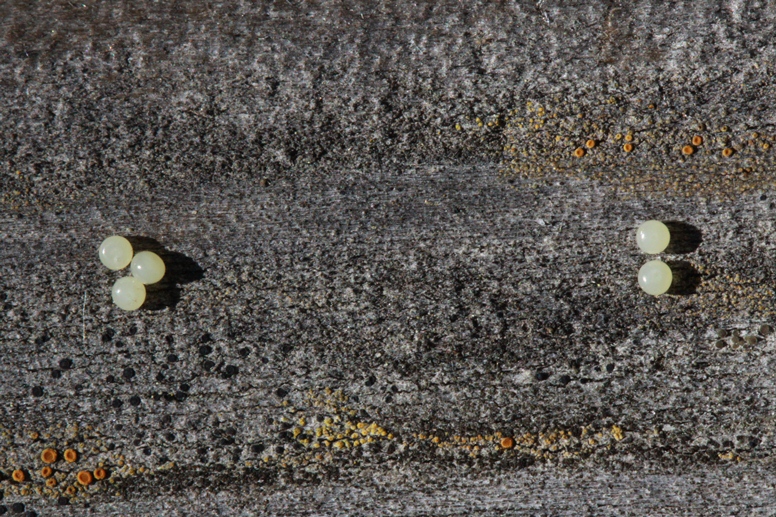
[99,235,166,311]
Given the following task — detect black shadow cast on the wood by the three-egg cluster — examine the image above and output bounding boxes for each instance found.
[127,236,205,311]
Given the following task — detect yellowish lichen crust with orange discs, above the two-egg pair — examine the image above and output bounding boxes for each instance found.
[500,95,776,199]
